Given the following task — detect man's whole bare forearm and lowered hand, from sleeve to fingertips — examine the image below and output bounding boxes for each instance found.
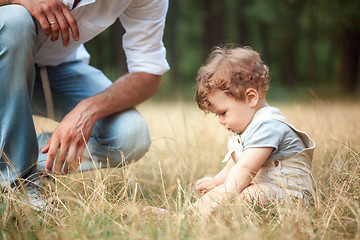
[41,72,161,174]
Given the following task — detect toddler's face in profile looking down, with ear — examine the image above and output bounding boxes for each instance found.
[208,90,256,133]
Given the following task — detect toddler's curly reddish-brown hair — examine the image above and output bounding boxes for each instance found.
[195,47,270,112]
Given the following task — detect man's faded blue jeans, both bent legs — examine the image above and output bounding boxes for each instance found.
[0,5,151,186]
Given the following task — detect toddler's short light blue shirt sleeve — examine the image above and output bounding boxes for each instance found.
[244,120,288,153]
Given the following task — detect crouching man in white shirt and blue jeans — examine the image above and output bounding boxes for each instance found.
[0,0,169,186]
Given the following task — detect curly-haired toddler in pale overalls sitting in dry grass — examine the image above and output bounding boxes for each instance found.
[194,47,315,212]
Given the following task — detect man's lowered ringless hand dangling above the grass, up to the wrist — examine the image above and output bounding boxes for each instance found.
[41,102,96,175]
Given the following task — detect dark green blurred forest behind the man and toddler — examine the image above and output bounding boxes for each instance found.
[86,0,360,101]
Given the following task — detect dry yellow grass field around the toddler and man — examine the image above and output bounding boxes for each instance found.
[0,101,360,240]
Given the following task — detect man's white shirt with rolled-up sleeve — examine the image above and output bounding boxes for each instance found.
[35,0,169,75]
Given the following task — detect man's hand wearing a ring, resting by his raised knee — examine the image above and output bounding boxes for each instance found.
[18,0,79,47]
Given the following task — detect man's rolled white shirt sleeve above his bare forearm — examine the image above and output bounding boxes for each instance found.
[120,0,170,75]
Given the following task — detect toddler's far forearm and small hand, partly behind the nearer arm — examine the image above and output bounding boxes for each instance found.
[195,159,235,193]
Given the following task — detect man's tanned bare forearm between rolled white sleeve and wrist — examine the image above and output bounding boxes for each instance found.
[80,72,161,121]
